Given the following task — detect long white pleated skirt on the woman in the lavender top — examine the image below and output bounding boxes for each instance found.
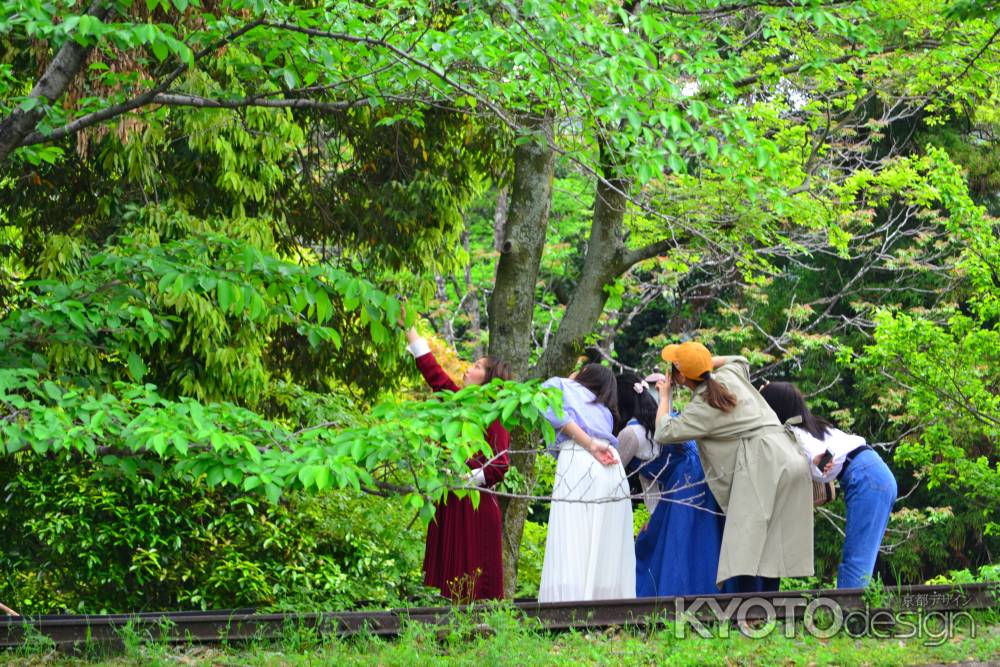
[538,441,635,602]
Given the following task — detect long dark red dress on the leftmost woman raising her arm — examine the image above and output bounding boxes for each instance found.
[417,353,510,600]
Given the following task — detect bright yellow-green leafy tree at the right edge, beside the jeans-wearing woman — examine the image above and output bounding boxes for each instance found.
[858,153,1000,534]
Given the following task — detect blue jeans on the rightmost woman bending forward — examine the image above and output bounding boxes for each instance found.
[837,449,896,588]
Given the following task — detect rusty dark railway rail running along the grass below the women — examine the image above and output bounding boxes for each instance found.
[0,583,1000,648]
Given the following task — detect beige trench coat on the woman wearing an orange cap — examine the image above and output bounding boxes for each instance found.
[654,357,813,587]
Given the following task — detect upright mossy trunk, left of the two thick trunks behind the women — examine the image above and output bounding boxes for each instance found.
[489,112,555,597]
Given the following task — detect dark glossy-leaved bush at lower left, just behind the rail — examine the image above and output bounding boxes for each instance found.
[0,457,426,613]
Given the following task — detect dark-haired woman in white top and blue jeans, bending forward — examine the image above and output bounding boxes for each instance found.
[760,382,896,588]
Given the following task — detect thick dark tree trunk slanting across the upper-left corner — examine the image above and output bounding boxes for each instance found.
[0,0,108,163]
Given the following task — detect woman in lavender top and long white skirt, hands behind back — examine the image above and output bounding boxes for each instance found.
[538,364,635,602]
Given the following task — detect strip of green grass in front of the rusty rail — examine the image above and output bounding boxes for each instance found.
[0,610,1000,667]
